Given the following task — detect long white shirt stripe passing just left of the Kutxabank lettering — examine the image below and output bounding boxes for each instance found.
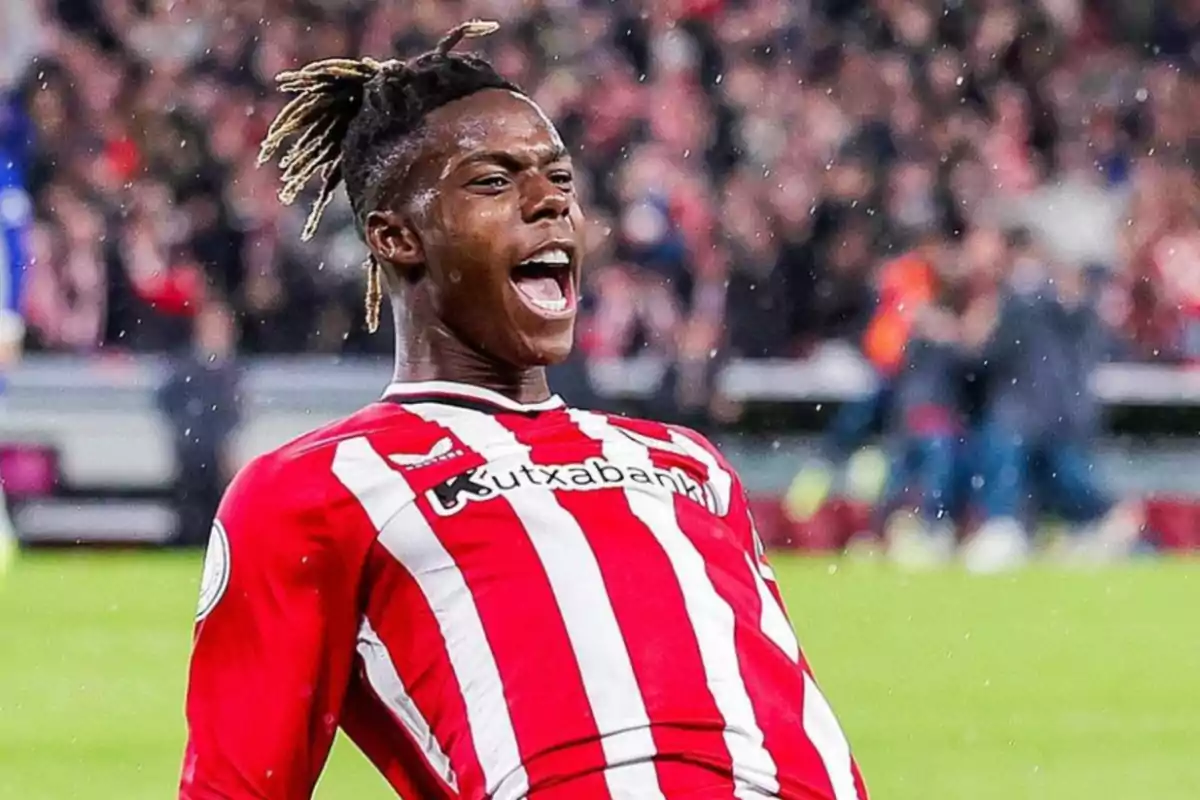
[334,437,529,800]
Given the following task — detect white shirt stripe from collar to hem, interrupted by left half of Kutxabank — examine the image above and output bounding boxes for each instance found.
[408,403,662,800]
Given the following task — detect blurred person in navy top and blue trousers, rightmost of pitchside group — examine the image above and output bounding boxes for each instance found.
[962,240,1141,572]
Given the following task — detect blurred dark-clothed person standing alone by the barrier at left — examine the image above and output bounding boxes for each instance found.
[158,301,241,546]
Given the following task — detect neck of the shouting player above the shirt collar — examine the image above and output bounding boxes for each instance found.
[392,299,551,403]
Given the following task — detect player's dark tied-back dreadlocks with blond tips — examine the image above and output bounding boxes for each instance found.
[258,19,521,332]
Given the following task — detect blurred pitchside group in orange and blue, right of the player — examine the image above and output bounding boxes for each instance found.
[785,227,1144,572]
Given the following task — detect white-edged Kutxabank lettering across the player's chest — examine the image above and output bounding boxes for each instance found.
[425,458,718,517]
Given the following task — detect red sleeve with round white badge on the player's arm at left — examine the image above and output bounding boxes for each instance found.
[179,457,361,800]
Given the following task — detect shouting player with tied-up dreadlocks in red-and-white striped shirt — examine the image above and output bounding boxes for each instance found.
[180,22,866,800]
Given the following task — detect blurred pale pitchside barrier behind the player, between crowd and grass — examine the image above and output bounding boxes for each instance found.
[0,343,1200,548]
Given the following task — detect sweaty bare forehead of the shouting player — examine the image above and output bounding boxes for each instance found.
[421,89,563,172]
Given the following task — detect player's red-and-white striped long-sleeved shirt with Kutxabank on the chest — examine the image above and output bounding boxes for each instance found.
[180,381,866,800]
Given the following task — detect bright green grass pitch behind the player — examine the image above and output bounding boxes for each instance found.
[0,553,1200,800]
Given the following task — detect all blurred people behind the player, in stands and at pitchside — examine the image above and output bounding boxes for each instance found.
[0,0,1200,556]
